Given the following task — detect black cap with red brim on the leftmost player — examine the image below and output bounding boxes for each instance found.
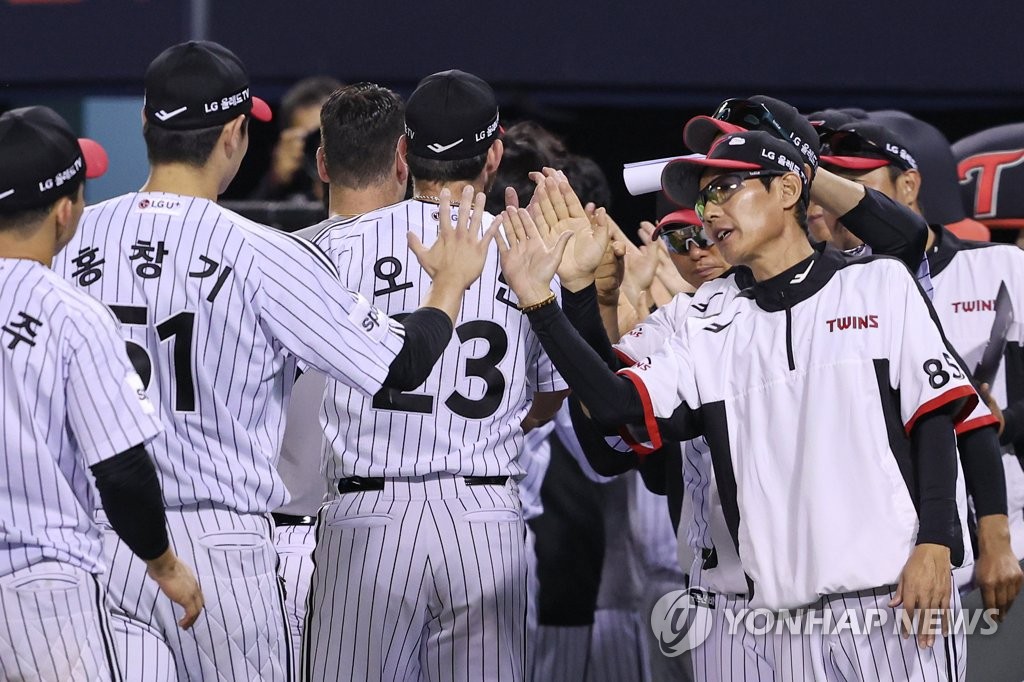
[0,106,109,213]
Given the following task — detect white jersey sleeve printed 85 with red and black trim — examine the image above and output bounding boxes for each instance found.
[887,263,978,434]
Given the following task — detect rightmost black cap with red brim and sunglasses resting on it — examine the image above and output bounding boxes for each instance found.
[821,121,918,171]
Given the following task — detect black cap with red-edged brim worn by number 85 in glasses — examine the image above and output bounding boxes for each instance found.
[662,130,807,207]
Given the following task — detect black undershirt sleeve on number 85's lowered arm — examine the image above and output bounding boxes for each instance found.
[910,413,961,549]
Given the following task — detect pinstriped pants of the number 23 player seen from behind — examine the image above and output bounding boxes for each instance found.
[302,475,526,682]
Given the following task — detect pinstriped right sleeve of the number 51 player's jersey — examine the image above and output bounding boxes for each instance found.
[250,238,404,395]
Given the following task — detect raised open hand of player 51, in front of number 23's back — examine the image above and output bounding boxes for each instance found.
[408,184,501,289]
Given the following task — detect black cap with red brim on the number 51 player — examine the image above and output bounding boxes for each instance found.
[145,40,272,130]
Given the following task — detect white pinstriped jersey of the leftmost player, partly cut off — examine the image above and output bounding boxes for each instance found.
[0,258,161,576]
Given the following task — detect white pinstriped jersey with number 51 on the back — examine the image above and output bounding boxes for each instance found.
[54,193,403,513]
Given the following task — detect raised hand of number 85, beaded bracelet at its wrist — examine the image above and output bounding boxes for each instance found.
[497,206,572,307]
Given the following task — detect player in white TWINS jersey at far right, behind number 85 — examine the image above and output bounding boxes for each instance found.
[822,122,1024,602]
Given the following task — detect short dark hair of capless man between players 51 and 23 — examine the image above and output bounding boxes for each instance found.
[321,83,406,189]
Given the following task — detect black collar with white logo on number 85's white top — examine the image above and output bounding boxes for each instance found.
[735,238,846,312]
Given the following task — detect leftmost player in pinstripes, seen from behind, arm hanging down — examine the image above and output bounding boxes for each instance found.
[0,106,203,682]
